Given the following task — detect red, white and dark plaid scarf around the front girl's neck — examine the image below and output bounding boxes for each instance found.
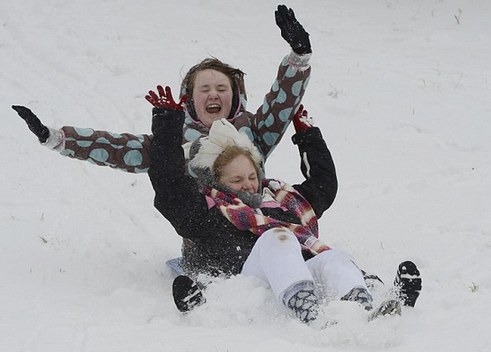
[204,179,330,255]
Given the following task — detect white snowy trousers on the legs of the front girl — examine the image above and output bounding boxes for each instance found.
[241,228,367,301]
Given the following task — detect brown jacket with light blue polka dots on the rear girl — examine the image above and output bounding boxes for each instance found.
[60,53,310,173]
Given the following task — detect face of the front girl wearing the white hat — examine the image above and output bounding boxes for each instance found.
[218,155,259,193]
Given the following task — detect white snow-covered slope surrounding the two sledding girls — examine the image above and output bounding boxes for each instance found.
[0,0,491,352]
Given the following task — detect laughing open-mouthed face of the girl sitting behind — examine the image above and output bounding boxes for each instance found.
[192,69,233,127]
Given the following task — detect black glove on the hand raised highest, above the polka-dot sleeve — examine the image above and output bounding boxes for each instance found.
[274,5,312,55]
